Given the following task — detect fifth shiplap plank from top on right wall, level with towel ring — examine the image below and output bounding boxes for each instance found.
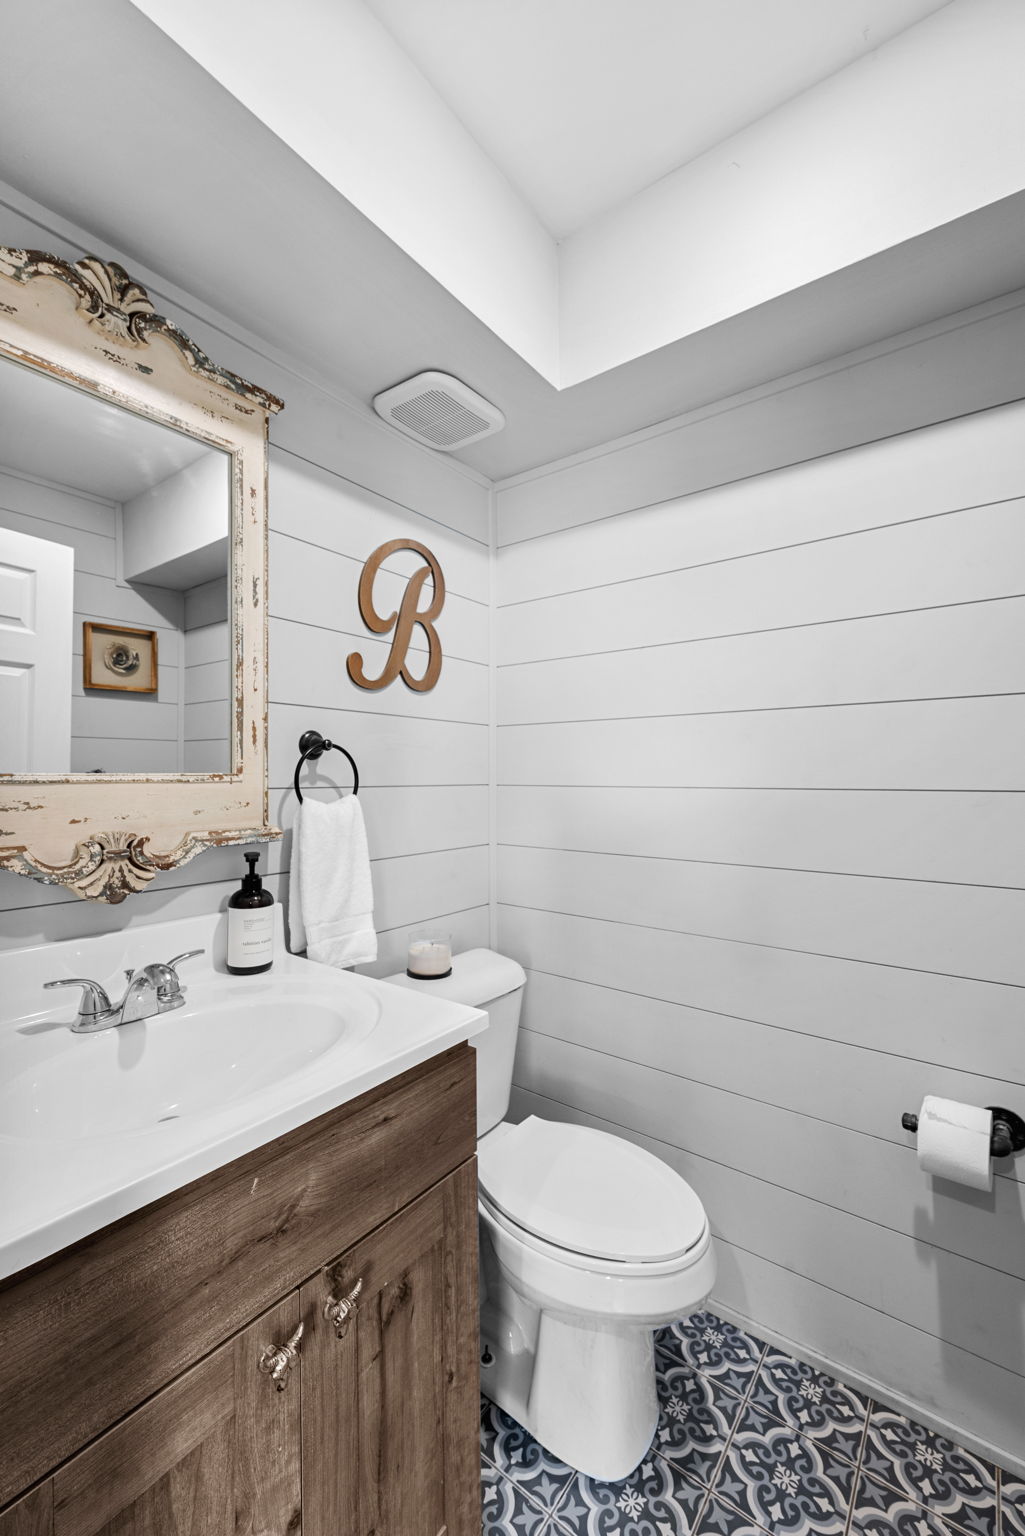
[498,696,1025,791]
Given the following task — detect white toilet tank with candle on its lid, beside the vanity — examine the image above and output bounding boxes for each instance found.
[384,949,527,1137]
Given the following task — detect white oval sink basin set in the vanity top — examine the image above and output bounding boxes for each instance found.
[0,977,380,1141]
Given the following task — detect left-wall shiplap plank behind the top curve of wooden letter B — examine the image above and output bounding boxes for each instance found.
[270,455,490,602]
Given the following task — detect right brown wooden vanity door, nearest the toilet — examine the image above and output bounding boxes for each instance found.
[301,1160,481,1536]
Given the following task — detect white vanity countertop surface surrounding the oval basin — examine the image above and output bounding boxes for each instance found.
[0,906,487,1279]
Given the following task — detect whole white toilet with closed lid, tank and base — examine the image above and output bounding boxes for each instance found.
[387,949,716,1482]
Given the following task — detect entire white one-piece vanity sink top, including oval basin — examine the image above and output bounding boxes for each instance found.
[0,906,486,1279]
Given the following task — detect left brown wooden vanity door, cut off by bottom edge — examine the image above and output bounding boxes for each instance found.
[50,1292,301,1536]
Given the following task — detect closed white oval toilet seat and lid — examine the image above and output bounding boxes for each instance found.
[478,1115,708,1275]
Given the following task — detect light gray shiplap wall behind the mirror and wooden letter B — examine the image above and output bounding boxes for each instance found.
[0,195,490,974]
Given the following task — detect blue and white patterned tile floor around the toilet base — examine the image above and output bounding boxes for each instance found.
[481,1312,1025,1536]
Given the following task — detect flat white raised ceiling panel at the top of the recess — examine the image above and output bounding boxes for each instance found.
[364,0,948,238]
